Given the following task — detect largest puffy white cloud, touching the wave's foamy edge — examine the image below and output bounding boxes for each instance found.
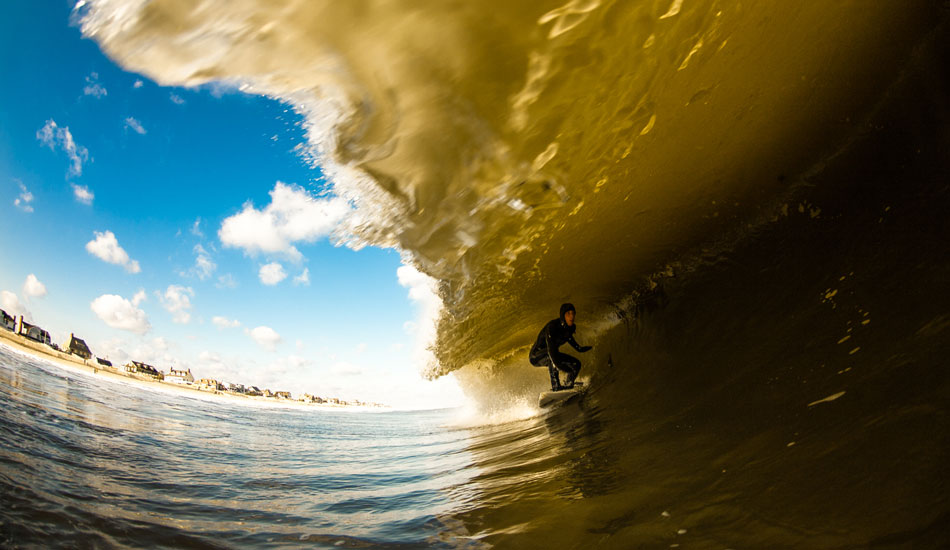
[218,182,350,261]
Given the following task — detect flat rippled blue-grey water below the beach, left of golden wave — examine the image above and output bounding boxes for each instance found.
[0,349,478,548]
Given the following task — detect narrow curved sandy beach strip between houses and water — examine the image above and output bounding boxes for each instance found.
[0,328,389,411]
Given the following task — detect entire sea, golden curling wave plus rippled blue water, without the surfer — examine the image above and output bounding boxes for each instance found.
[0,0,950,549]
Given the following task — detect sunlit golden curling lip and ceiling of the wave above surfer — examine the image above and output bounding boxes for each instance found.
[77,0,942,375]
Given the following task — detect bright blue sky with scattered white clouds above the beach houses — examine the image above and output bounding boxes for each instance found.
[0,2,460,406]
